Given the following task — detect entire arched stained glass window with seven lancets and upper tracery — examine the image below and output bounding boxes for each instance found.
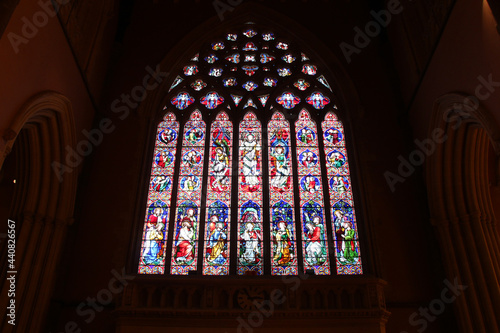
[138,23,363,275]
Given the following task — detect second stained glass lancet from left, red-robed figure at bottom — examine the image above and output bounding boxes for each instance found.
[170,110,205,275]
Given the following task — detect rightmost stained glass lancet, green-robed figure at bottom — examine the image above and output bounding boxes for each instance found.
[322,112,363,274]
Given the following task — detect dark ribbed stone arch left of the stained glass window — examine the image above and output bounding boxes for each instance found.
[0,91,78,332]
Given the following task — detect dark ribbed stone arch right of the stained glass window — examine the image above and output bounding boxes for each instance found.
[426,93,500,332]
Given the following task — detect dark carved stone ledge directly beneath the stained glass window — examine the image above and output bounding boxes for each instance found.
[114,276,390,332]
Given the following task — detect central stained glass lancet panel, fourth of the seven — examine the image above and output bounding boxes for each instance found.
[237,112,263,275]
